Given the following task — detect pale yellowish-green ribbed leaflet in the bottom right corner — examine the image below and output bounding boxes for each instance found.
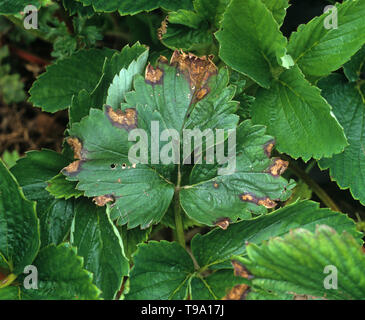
[241,226,365,300]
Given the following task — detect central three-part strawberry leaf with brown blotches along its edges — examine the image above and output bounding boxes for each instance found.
[63,52,290,228]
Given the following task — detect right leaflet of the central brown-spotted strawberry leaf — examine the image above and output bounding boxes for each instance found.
[180,120,290,226]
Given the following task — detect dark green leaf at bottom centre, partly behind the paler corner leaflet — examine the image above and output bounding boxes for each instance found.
[127,201,360,299]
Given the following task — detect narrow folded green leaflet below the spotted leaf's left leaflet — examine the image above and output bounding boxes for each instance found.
[72,199,129,300]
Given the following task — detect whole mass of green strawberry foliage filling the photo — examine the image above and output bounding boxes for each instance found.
[0,0,365,300]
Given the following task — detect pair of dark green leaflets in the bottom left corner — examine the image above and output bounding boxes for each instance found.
[0,159,99,300]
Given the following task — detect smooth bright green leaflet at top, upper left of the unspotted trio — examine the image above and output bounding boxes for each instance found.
[216,0,287,88]
